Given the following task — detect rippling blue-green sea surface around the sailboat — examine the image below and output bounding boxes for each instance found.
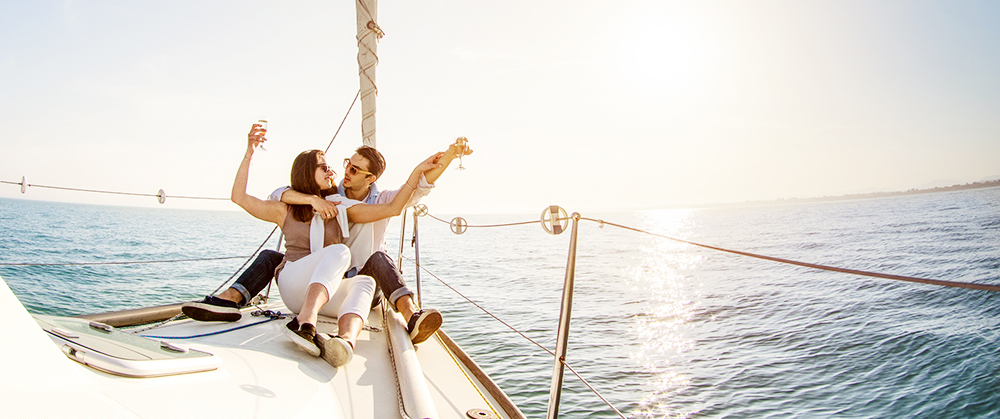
[0,188,1000,418]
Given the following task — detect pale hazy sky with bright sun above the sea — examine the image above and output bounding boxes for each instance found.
[0,0,1000,215]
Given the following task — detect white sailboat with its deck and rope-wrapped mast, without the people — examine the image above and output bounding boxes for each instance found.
[0,0,524,419]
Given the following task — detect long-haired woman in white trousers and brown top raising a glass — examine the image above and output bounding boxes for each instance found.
[231,124,440,367]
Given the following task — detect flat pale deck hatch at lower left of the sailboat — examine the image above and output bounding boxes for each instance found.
[34,316,222,378]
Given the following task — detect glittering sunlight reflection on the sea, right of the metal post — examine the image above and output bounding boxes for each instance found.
[629,210,703,418]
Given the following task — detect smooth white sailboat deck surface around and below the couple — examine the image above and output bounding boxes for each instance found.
[0,276,508,419]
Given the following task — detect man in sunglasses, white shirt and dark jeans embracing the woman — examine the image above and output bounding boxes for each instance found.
[182,138,472,344]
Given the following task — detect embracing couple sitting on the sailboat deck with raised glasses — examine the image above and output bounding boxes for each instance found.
[182,124,472,367]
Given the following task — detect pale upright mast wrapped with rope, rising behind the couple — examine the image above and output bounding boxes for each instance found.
[356,0,384,147]
